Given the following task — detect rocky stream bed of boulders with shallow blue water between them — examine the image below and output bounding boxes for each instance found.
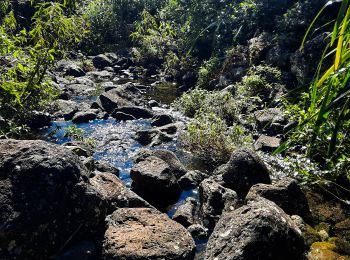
[0,54,350,260]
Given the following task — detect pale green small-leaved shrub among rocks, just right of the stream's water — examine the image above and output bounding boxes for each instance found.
[185,112,252,163]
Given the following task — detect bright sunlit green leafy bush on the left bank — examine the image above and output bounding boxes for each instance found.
[0,2,84,135]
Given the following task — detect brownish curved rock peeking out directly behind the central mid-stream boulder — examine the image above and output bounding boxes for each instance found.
[134,149,187,178]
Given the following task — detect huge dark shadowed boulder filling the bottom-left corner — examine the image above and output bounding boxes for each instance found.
[0,140,105,259]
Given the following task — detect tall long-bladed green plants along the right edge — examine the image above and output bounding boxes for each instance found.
[277,0,350,180]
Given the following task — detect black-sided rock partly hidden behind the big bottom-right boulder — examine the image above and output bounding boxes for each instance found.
[246,177,310,219]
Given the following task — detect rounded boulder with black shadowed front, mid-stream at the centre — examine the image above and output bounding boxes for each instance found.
[130,156,181,208]
